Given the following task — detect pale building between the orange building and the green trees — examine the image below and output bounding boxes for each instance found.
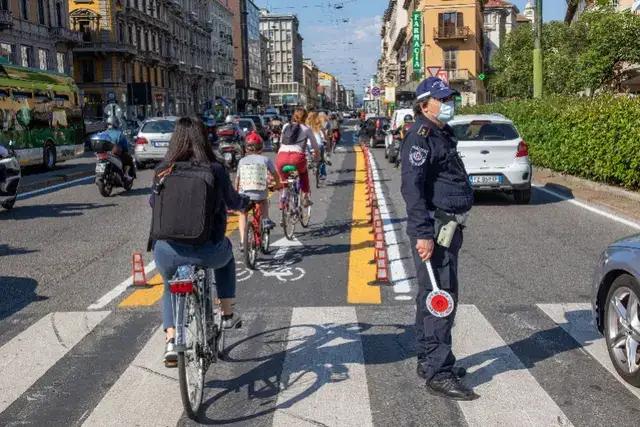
[484,0,520,67]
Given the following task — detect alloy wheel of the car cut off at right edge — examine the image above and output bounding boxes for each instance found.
[604,274,640,387]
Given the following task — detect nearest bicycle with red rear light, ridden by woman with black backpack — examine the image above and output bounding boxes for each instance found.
[169,265,228,419]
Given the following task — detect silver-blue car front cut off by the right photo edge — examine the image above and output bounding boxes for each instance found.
[592,234,640,387]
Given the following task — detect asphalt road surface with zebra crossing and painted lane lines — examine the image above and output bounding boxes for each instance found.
[0,121,640,426]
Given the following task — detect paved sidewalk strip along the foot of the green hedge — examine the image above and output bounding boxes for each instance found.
[533,167,640,222]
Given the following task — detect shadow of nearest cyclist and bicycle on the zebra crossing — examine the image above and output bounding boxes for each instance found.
[198,323,414,424]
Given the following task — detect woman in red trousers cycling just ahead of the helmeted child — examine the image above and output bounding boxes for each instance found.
[276,107,320,207]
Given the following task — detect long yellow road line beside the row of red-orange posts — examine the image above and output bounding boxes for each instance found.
[347,147,382,304]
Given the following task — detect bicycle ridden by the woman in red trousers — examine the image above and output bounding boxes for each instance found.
[280,165,311,240]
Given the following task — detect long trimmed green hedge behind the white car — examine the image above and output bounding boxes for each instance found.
[461,95,640,190]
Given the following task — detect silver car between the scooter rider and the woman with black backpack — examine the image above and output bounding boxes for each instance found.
[134,116,178,169]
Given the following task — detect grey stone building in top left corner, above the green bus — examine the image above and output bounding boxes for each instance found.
[0,0,82,75]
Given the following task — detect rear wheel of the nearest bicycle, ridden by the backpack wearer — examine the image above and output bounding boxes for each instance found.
[178,294,205,419]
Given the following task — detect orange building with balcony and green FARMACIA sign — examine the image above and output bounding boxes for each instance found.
[378,0,486,105]
